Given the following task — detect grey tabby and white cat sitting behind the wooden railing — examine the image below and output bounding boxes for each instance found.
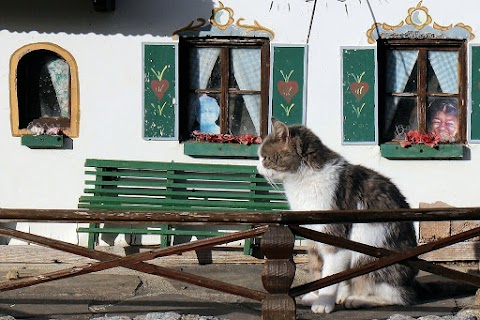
[257,119,418,313]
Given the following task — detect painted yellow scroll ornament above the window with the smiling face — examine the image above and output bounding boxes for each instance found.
[367,0,475,44]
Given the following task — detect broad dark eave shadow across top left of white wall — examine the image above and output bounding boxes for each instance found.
[0,0,214,36]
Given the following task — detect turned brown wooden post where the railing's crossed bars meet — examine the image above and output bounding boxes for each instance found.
[260,226,296,320]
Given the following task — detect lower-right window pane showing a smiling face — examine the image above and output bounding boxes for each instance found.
[427,98,459,142]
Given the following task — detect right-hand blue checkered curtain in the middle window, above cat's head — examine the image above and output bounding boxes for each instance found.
[231,49,261,135]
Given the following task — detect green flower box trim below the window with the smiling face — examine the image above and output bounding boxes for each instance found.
[380,143,464,159]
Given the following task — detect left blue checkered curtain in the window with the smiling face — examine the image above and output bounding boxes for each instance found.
[384,50,418,130]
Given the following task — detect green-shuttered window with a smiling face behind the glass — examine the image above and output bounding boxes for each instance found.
[342,39,466,159]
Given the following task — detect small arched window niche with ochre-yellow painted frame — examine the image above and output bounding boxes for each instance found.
[10,42,79,138]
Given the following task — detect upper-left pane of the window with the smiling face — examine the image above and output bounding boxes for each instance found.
[386,50,418,93]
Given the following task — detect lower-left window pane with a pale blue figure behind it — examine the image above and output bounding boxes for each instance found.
[188,94,220,133]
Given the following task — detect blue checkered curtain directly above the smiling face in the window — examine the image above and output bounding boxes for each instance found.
[428,51,458,93]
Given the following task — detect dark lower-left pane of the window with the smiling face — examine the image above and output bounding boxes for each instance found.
[383,97,418,141]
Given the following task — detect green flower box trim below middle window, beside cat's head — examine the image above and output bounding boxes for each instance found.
[183,141,259,159]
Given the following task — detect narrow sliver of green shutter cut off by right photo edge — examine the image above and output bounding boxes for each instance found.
[469,46,480,142]
